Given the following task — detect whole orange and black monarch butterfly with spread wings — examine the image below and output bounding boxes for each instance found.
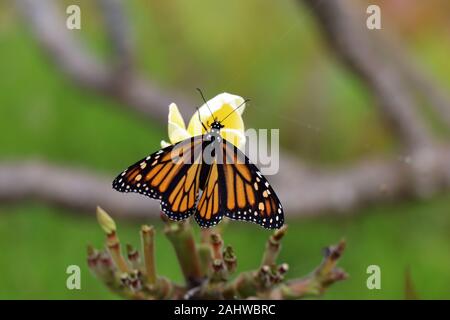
[113,95,284,229]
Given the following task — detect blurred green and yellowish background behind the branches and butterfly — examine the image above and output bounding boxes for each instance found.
[0,0,450,299]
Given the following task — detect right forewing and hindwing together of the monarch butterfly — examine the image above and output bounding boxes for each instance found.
[195,139,284,229]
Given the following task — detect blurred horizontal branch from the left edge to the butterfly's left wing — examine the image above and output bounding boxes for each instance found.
[0,161,160,217]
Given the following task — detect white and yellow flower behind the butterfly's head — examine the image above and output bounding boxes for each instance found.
[161,93,245,149]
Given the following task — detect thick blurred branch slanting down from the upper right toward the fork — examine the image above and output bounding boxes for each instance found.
[302,0,431,149]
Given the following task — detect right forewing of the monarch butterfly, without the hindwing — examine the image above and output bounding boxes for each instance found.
[222,140,284,229]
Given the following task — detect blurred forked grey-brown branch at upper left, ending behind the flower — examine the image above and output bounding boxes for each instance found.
[16,0,190,121]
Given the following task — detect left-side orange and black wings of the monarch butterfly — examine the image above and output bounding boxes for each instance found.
[113,136,203,220]
